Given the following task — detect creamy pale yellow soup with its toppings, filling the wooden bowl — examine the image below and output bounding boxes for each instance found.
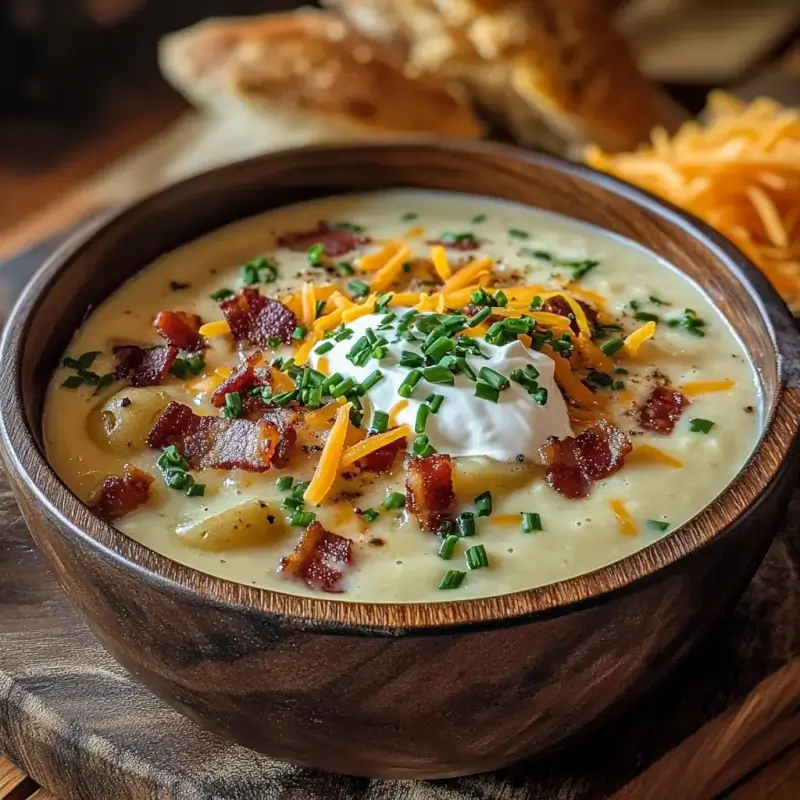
[44,190,761,602]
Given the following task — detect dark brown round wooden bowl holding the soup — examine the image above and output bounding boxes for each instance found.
[0,140,800,778]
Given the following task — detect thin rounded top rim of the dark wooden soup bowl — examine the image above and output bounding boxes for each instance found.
[0,137,800,636]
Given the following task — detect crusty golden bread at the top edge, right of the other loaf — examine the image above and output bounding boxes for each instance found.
[327,0,684,150]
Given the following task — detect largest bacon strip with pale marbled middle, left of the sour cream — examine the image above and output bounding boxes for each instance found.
[147,401,281,472]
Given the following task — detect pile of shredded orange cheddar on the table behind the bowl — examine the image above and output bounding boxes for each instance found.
[585,92,800,312]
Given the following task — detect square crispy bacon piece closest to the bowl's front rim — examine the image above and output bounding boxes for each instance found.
[278,522,353,592]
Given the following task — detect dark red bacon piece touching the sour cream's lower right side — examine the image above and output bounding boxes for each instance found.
[539,420,632,500]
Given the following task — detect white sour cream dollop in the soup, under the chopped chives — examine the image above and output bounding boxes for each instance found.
[309,314,572,462]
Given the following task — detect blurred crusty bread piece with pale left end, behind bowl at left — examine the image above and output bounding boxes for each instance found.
[160,9,482,147]
